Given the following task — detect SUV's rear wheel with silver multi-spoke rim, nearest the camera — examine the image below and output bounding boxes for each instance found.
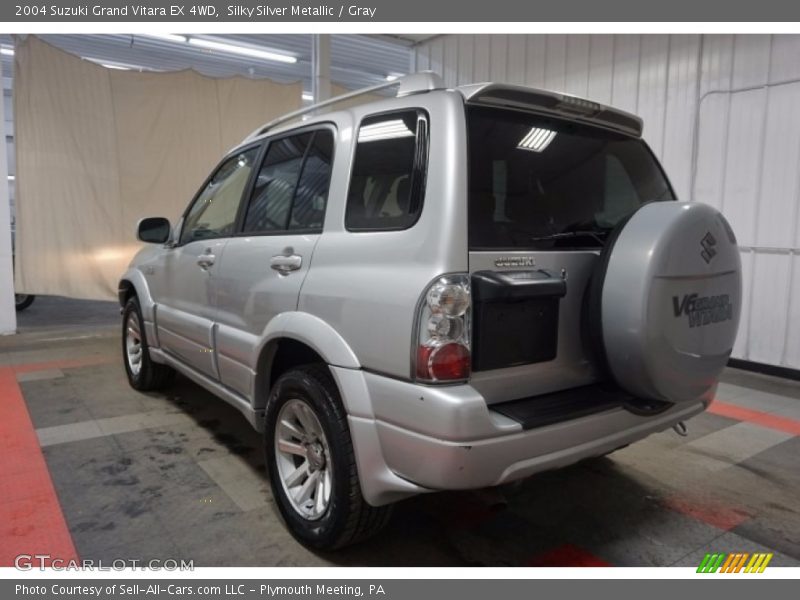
[265,365,391,550]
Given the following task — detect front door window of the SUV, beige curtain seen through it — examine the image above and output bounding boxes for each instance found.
[180,148,258,244]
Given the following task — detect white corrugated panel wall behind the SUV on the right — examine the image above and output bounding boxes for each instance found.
[411,35,800,369]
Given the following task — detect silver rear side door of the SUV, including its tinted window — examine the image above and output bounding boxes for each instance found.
[216,127,335,398]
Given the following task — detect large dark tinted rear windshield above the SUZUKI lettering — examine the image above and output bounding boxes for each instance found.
[467,108,675,250]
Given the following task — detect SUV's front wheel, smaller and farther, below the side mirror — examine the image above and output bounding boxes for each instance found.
[122,296,175,392]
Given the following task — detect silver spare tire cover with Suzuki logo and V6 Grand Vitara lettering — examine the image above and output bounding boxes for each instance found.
[587,202,742,403]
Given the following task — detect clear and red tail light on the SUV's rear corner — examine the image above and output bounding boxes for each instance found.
[413,274,472,382]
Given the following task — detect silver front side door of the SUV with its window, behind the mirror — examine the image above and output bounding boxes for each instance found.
[148,146,258,379]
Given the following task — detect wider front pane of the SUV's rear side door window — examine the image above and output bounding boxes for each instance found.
[243,133,312,233]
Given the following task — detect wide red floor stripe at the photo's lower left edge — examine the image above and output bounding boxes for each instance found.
[0,367,78,567]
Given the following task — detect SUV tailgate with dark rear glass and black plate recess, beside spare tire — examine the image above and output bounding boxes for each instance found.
[467,107,674,403]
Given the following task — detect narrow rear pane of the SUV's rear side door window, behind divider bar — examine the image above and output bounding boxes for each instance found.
[289,129,333,229]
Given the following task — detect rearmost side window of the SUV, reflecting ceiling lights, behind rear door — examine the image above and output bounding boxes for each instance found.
[345,110,428,231]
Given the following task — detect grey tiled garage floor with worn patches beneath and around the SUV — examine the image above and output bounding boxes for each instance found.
[0,300,800,566]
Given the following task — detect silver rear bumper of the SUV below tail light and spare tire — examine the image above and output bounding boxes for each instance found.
[332,367,706,505]
